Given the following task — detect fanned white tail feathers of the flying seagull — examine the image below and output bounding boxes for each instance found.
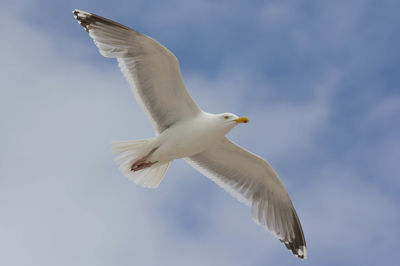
[111,139,171,188]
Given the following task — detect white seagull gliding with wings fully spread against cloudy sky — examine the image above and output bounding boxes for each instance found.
[73,9,307,259]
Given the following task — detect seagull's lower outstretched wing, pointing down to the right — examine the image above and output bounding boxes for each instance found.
[186,137,307,259]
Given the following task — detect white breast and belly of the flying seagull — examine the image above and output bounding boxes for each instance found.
[150,115,224,162]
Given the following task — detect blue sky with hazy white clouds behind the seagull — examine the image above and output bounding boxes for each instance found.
[0,0,400,266]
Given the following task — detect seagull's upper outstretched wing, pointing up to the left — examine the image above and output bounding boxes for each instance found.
[73,9,200,133]
